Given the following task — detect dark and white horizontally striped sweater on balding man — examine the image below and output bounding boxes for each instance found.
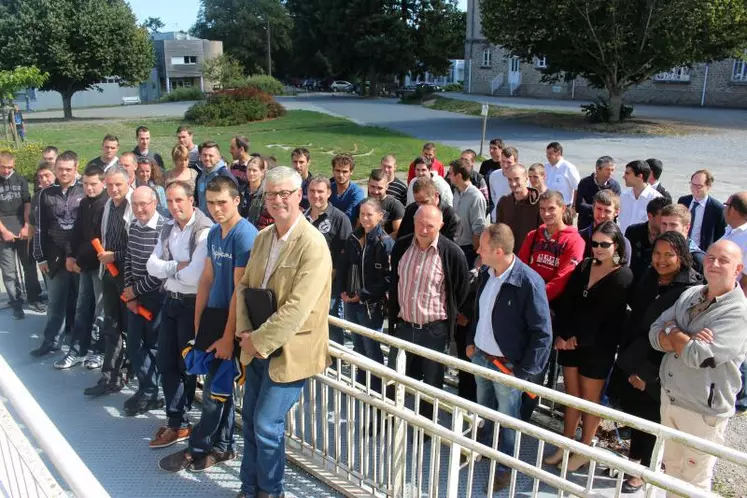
[125,212,164,296]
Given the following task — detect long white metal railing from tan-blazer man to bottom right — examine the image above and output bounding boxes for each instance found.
[276,317,747,497]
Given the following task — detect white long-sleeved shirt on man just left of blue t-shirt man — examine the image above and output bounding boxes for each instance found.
[146,214,210,294]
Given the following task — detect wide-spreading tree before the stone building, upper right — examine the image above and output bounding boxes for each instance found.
[480,0,747,122]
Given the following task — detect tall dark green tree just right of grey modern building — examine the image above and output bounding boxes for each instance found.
[191,0,292,74]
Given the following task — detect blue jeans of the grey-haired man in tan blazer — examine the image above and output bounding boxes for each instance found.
[239,358,306,498]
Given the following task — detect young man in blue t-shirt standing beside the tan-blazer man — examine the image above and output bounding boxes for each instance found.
[159,176,257,472]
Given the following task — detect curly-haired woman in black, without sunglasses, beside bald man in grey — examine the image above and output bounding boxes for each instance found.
[610,232,703,493]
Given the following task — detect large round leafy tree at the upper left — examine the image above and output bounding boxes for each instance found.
[0,0,154,119]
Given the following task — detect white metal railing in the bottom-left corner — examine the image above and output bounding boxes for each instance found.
[0,355,109,498]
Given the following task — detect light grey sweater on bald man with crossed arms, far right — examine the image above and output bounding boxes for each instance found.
[649,285,747,417]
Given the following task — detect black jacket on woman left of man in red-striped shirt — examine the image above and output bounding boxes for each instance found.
[335,225,394,304]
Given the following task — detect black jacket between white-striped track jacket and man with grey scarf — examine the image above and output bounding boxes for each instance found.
[67,190,109,270]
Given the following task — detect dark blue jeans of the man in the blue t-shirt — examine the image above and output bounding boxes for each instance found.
[189,358,238,453]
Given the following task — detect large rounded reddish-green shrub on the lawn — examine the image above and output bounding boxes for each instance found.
[184,87,285,126]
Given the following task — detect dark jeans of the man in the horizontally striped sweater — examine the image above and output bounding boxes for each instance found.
[127,292,163,399]
